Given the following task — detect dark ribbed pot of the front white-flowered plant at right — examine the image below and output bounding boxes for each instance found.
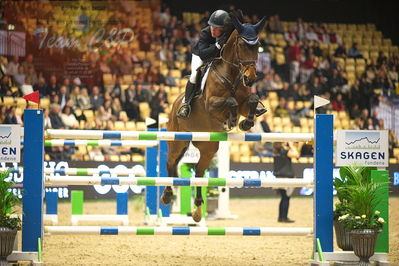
[350,229,380,265]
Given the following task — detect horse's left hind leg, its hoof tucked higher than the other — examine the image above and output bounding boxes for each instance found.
[161,141,190,205]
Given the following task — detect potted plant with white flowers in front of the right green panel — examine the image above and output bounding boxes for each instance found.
[338,175,386,265]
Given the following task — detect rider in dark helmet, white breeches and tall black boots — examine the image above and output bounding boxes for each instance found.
[176,10,230,119]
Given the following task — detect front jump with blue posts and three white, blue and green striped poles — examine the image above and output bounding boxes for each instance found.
[17,110,390,265]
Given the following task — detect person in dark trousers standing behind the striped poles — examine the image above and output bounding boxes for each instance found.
[273,142,299,223]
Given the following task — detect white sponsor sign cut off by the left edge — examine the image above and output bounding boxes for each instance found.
[0,125,21,163]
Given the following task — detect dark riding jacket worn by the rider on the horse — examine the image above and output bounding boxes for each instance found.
[192,26,219,61]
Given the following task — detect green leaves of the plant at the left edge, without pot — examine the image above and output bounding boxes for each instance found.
[0,170,21,229]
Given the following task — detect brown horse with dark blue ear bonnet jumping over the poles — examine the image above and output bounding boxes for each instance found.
[161,16,266,222]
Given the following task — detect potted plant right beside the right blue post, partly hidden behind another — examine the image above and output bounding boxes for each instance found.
[334,165,376,251]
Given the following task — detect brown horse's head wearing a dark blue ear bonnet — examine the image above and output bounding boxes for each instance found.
[232,16,266,86]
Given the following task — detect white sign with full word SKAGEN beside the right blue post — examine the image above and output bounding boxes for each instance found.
[335,130,389,167]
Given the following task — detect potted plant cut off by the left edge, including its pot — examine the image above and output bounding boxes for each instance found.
[0,171,21,265]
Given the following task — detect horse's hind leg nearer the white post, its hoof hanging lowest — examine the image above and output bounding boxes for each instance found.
[192,142,219,222]
